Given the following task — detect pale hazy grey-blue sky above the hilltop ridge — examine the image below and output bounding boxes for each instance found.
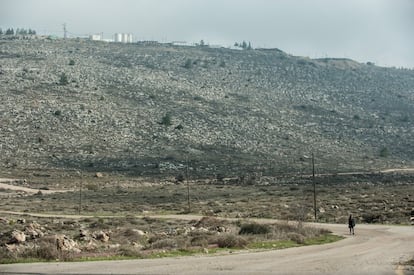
[0,0,414,68]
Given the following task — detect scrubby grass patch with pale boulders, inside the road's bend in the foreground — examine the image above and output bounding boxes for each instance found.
[0,216,336,263]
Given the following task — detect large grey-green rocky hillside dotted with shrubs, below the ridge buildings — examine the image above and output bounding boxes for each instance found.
[0,39,414,176]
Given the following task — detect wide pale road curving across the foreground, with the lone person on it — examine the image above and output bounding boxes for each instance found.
[0,219,414,275]
